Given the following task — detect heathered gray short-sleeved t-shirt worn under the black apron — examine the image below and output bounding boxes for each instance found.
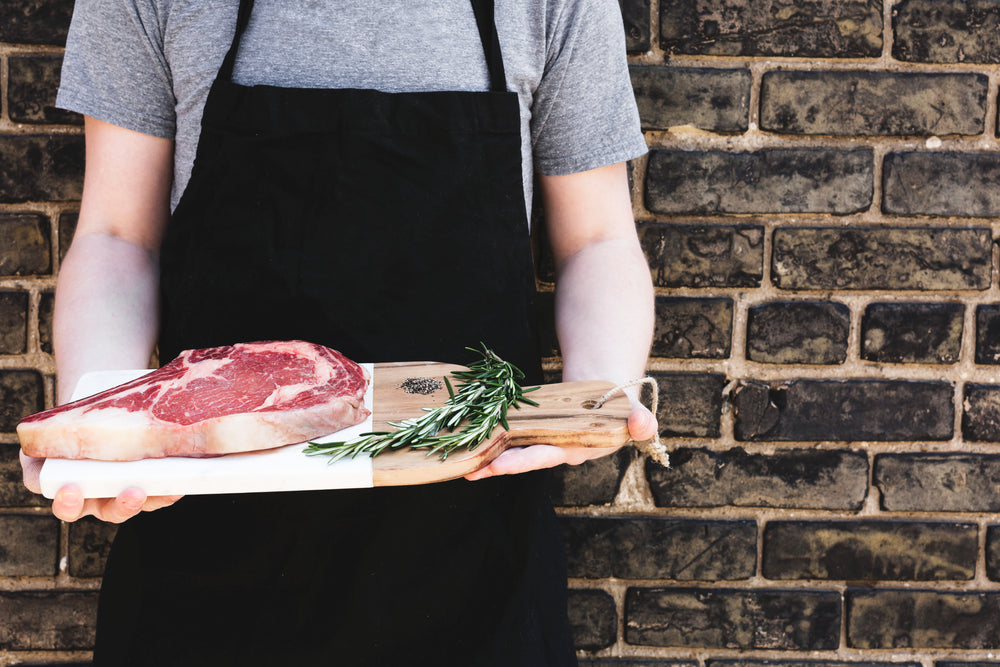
[57,0,646,213]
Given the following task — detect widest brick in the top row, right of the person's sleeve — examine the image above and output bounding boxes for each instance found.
[660,0,882,58]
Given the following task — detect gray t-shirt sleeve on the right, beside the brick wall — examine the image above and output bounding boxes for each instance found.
[531,0,647,176]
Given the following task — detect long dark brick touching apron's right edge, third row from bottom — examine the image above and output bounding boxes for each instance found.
[562,517,757,581]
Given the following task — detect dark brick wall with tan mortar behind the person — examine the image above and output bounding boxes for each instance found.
[0,0,1000,667]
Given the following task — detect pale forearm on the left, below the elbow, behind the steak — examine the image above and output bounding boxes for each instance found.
[53,233,159,403]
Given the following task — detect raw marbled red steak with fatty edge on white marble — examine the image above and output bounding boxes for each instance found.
[17,341,369,461]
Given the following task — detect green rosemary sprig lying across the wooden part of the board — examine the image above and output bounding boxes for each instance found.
[305,345,538,463]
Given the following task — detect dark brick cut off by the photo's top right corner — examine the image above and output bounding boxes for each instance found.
[892,0,1000,63]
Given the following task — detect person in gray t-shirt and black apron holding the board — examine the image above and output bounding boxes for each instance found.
[22,0,656,667]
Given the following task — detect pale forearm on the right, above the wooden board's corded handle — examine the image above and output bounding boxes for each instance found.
[555,238,654,384]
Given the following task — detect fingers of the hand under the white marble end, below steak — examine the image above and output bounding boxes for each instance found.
[20,451,182,523]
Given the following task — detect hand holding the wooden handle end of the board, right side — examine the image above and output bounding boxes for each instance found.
[465,405,658,480]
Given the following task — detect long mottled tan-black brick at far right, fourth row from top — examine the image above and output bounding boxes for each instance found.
[772,227,993,290]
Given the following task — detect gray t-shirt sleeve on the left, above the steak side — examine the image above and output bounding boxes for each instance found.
[56,0,175,139]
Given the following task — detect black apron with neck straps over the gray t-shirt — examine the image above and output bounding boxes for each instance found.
[95,0,576,667]
